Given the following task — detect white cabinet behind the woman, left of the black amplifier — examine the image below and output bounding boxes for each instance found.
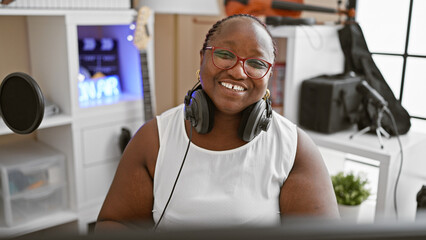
[270,25,344,123]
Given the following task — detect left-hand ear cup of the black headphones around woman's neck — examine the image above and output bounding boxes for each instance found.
[185,89,214,134]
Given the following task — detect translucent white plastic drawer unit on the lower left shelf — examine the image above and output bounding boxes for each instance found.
[0,141,68,226]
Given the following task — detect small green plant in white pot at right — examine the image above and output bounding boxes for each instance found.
[331,172,371,221]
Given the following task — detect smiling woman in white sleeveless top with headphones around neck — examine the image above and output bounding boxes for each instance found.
[96,15,339,232]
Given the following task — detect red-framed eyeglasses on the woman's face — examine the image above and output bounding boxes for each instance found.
[204,47,272,79]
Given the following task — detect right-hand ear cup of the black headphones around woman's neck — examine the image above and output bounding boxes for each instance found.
[238,100,271,142]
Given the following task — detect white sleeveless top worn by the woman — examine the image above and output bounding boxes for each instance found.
[153,104,297,229]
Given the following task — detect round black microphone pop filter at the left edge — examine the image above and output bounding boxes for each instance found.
[0,72,44,134]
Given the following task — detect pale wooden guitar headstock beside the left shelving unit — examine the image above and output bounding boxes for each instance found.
[133,6,151,50]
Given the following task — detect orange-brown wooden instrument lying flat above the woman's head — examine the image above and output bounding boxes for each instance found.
[225,0,303,17]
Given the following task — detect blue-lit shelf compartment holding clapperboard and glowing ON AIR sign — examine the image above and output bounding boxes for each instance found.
[76,24,143,107]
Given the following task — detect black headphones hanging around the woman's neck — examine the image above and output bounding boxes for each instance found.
[184,82,272,142]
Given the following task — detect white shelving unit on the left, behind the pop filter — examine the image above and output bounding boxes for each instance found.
[0,8,154,237]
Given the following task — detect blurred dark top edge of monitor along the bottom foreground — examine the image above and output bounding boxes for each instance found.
[20,219,426,240]
